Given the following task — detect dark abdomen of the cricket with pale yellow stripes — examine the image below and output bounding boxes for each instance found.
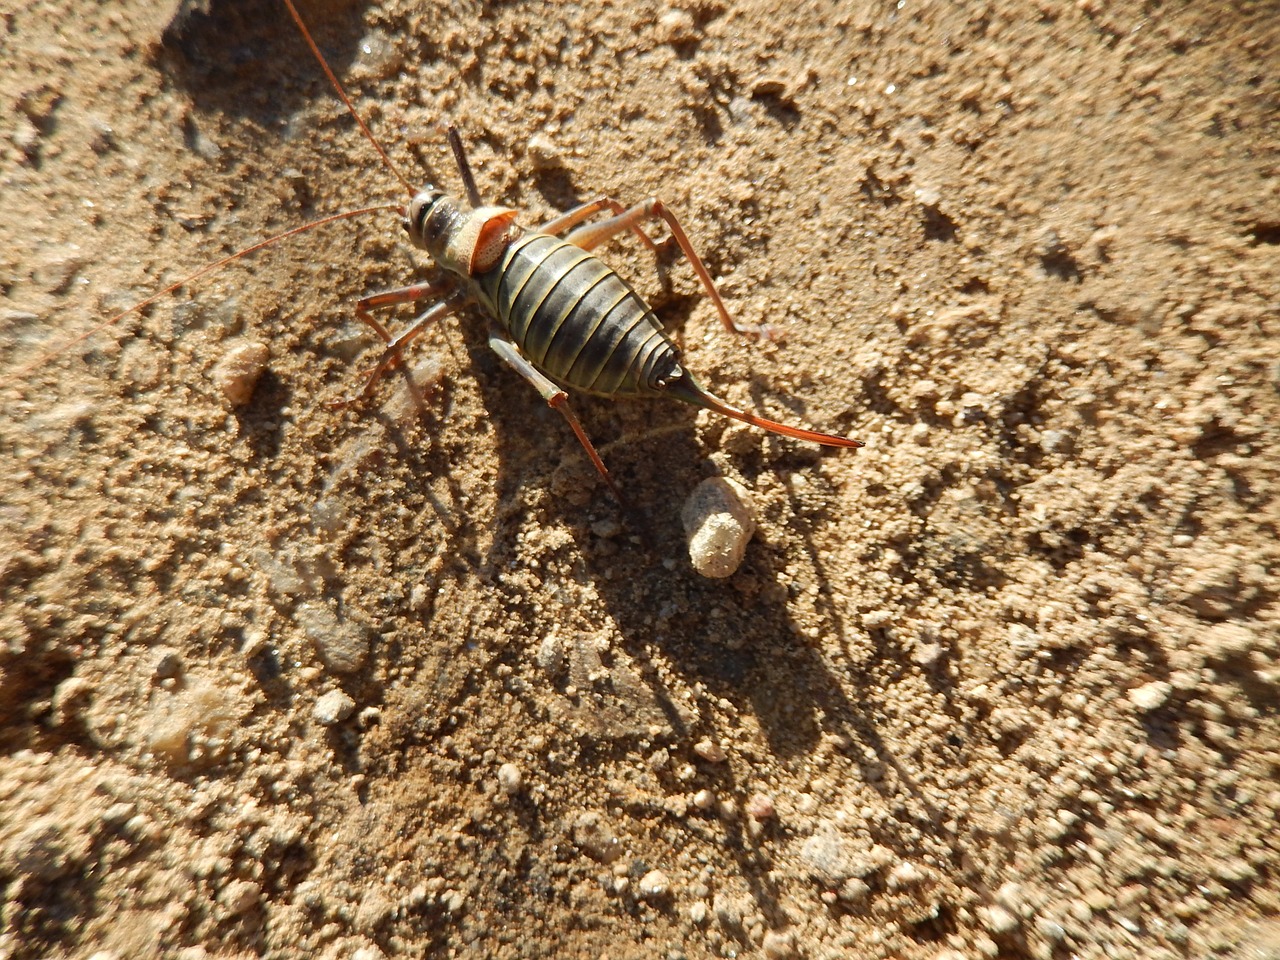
[472,233,680,397]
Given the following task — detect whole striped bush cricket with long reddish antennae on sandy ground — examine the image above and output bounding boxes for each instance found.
[10,0,863,500]
